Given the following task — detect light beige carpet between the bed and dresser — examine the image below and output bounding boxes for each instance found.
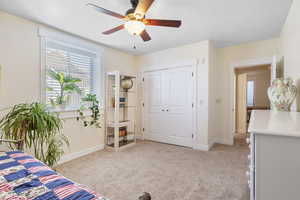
[57,141,249,200]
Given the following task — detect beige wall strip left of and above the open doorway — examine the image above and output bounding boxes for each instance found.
[216,38,280,144]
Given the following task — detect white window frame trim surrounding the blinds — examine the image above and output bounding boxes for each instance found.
[38,26,105,115]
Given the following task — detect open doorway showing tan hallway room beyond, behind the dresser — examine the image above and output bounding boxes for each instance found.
[234,64,272,145]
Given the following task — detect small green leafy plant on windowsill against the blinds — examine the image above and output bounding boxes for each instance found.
[48,69,81,106]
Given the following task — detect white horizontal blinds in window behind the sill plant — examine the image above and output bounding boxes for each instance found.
[44,40,97,109]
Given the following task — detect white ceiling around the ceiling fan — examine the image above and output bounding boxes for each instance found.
[0,0,292,55]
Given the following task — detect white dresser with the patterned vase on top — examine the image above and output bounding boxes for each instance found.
[247,111,300,200]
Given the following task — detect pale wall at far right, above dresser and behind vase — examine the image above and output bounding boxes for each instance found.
[281,0,300,111]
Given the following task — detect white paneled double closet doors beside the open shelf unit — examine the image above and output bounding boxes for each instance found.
[144,67,194,147]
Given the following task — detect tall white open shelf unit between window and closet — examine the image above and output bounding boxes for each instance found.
[105,71,138,151]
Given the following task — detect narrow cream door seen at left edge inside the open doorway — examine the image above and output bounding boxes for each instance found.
[236,74,247,134]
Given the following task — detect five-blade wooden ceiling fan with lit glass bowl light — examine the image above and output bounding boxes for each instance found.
[87,0,181,42]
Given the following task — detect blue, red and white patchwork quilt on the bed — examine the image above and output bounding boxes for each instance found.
[0,151,108,200]
